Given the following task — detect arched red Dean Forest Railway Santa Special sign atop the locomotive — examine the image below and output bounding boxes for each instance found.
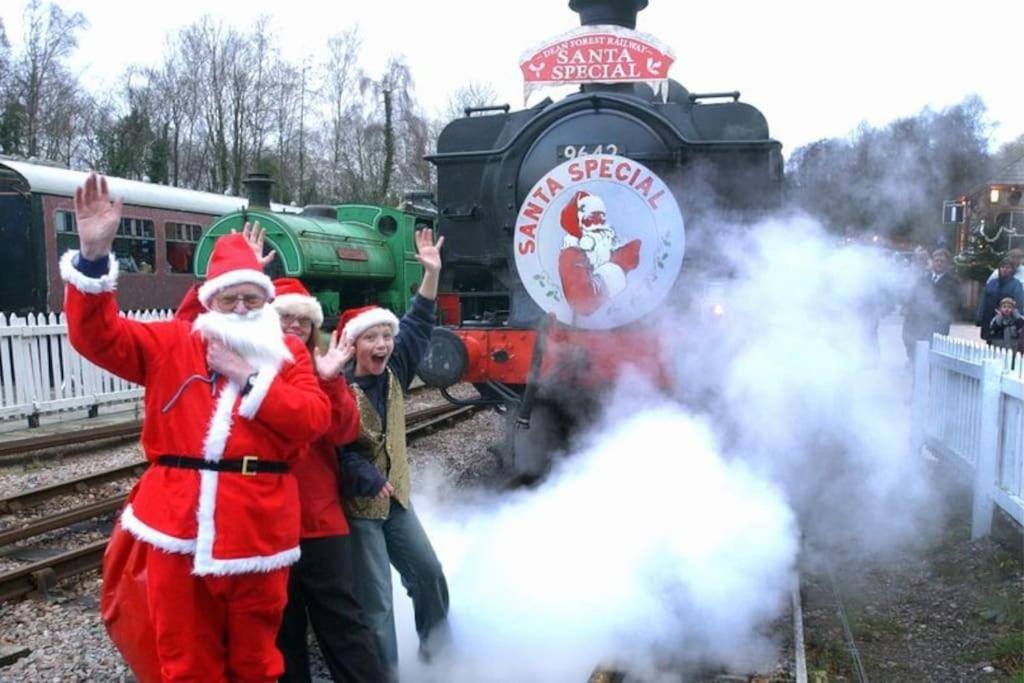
[519,26,675,89]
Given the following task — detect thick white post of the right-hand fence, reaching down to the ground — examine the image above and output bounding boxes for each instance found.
[971,358,1002,539]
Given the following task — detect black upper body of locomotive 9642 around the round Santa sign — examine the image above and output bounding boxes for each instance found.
[430,0,782,328]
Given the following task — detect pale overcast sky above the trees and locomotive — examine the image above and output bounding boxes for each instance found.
[0,0,1024,155]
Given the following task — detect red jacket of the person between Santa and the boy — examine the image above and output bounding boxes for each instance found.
[295,377,359,539]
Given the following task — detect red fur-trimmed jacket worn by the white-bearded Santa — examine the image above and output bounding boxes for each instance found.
[60,253,331,575]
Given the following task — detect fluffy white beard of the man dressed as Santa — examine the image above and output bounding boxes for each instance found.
[193,305,294,368]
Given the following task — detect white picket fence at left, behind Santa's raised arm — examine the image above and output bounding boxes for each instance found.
[0,310,173,427]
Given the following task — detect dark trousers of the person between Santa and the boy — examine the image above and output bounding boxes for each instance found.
[278,536,385,683]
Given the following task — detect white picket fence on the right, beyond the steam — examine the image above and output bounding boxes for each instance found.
[911,335,1024,538]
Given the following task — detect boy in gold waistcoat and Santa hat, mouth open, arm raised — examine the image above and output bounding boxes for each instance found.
[338,229,449,680]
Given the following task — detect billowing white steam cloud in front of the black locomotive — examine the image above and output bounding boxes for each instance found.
[395,211,929,683]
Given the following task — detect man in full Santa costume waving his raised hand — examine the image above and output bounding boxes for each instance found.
[60,174,331,681]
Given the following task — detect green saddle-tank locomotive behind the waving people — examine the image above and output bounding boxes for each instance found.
[194,173,436,328]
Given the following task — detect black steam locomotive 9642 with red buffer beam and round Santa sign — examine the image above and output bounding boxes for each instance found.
[420,0,782,476]
